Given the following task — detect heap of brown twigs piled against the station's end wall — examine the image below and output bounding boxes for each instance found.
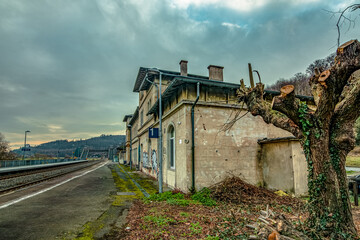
[210,176,303,208]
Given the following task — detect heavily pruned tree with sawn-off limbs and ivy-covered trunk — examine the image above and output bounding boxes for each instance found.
[238,40,360,239]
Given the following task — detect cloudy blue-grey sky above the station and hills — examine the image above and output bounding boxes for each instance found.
[0,0,360,147]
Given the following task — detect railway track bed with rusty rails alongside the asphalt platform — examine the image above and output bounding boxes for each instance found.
[0,161,99,195]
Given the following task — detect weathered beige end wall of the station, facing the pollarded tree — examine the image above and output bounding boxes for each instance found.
[191,102,289,189]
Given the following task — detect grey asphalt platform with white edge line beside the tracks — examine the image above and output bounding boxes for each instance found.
[0,162,129,240]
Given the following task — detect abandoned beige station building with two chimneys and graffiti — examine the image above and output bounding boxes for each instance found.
[123,60,307,195]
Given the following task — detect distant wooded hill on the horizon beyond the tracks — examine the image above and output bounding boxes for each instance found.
[13,134,125,157]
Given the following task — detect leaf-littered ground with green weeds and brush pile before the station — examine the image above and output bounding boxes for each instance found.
[113,175,360,240]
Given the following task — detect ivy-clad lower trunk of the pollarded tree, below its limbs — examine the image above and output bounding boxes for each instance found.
[302,129,356,239]
